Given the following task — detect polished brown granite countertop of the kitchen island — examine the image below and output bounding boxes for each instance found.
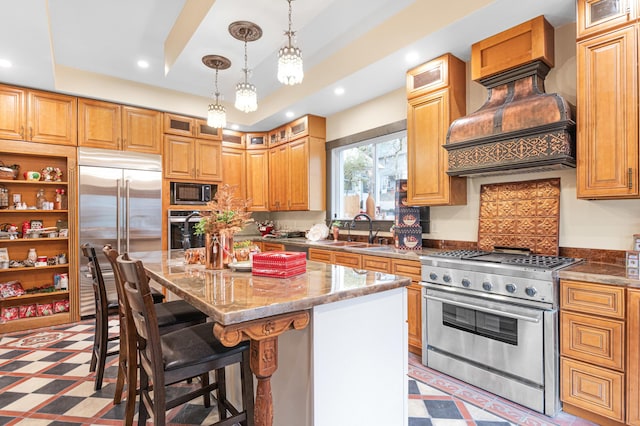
[138,251,411,325]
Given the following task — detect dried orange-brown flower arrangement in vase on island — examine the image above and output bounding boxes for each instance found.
[195,184,253,237]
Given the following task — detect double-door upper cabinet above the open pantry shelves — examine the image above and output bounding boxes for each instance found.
[0,85,77,146]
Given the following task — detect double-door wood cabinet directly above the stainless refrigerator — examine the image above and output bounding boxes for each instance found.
[78,98,162,154]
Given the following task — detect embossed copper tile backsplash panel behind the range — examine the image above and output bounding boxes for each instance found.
[478,178,560,256]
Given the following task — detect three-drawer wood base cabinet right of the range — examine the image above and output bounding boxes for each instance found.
[560,280,640,425]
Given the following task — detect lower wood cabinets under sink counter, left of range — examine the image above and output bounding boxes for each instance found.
[309,248,422,355]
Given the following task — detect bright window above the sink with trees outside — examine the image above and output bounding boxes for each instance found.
[331,130,407,220]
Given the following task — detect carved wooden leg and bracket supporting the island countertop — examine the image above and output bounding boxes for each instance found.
[213,311,309,426]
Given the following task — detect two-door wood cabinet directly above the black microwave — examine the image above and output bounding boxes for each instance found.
[163,135,222,182]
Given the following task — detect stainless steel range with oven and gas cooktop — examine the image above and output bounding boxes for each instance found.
[421,250,581,416]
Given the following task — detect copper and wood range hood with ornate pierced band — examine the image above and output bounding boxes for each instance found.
[444,16,576,176]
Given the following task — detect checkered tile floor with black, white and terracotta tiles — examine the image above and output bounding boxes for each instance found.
[0,320,591,426]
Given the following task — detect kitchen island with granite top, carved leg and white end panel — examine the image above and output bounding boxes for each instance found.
[139,252,410,426]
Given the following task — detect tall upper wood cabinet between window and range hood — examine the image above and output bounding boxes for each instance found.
[407,54,467,206]
